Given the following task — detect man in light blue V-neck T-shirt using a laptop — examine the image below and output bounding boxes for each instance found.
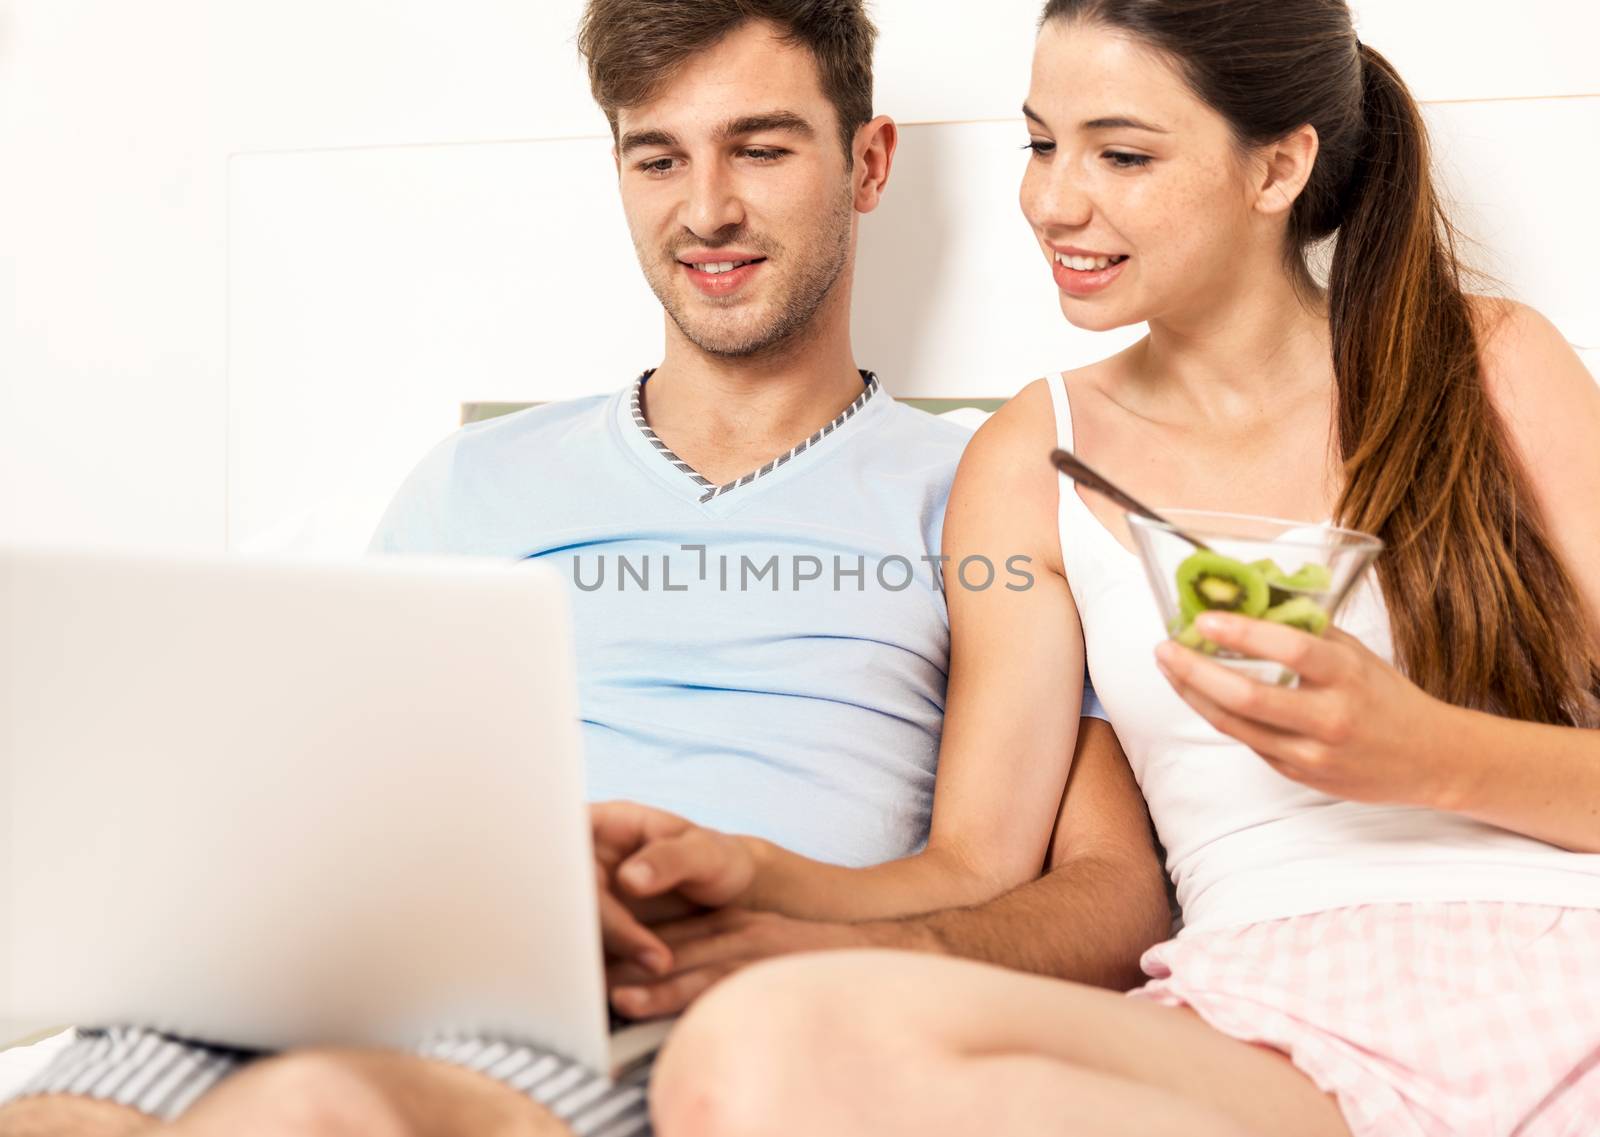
[0,0,1154,1137]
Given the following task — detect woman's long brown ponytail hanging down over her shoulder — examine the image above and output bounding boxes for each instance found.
[1328,45,1600,724]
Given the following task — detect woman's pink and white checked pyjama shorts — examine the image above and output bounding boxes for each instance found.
[1131,904,1600,1137]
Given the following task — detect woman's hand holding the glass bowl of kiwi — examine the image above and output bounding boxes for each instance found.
[1155,612,1456,808]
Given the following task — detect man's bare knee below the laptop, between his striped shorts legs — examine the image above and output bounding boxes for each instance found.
[162,1051,568,1137]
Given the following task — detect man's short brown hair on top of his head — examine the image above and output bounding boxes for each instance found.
[578,0,877,162]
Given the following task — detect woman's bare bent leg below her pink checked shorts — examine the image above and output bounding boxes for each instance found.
[653,951,1349,1137]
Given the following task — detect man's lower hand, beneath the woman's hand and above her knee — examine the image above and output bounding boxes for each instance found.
[606,908,917,1019]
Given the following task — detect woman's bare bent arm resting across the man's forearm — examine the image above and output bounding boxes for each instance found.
[601,382,1147,920]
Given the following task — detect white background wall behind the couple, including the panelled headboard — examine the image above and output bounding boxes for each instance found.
[0,0,1600,547]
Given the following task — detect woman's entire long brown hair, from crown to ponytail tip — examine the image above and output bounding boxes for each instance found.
[1045,0,1600,726]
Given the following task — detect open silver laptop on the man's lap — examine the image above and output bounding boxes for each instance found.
[0,550,664,1073]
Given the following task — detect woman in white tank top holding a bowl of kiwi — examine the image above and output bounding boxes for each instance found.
[643,0,1600,1137]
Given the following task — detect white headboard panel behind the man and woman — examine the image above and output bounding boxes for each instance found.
[229,99,1600,556]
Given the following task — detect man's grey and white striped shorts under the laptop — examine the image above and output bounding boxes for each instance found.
[7,1027,650,1137]
